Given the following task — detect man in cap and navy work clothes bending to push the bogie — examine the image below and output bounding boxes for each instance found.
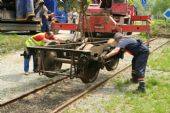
[103,33,149,92]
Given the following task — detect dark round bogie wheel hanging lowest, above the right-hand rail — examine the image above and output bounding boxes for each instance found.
[81,61,100,83]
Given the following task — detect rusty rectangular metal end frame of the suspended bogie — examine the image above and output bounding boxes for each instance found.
[28,40,106,78]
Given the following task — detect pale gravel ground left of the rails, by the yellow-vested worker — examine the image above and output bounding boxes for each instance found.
[0,30,76,103]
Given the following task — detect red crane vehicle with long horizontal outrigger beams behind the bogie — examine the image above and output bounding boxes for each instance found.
[51,0,151,36]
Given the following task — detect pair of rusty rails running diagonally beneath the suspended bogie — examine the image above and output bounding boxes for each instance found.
[0,39,169,113]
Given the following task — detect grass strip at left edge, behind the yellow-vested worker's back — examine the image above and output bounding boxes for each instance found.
[0,34,26,55]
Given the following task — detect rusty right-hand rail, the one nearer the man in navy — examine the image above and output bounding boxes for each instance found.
[50,39,170,113]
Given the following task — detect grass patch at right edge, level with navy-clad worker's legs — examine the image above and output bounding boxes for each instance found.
[149,45,170,71]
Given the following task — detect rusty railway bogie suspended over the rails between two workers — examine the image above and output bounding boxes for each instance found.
[28,41,118,83]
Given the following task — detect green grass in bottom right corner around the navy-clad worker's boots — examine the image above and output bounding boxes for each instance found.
[102,73,170,113]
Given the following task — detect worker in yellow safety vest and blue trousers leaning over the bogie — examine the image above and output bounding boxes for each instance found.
[24,32,61,75]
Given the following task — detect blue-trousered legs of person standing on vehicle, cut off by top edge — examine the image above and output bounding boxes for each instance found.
[16,0,35,20]
